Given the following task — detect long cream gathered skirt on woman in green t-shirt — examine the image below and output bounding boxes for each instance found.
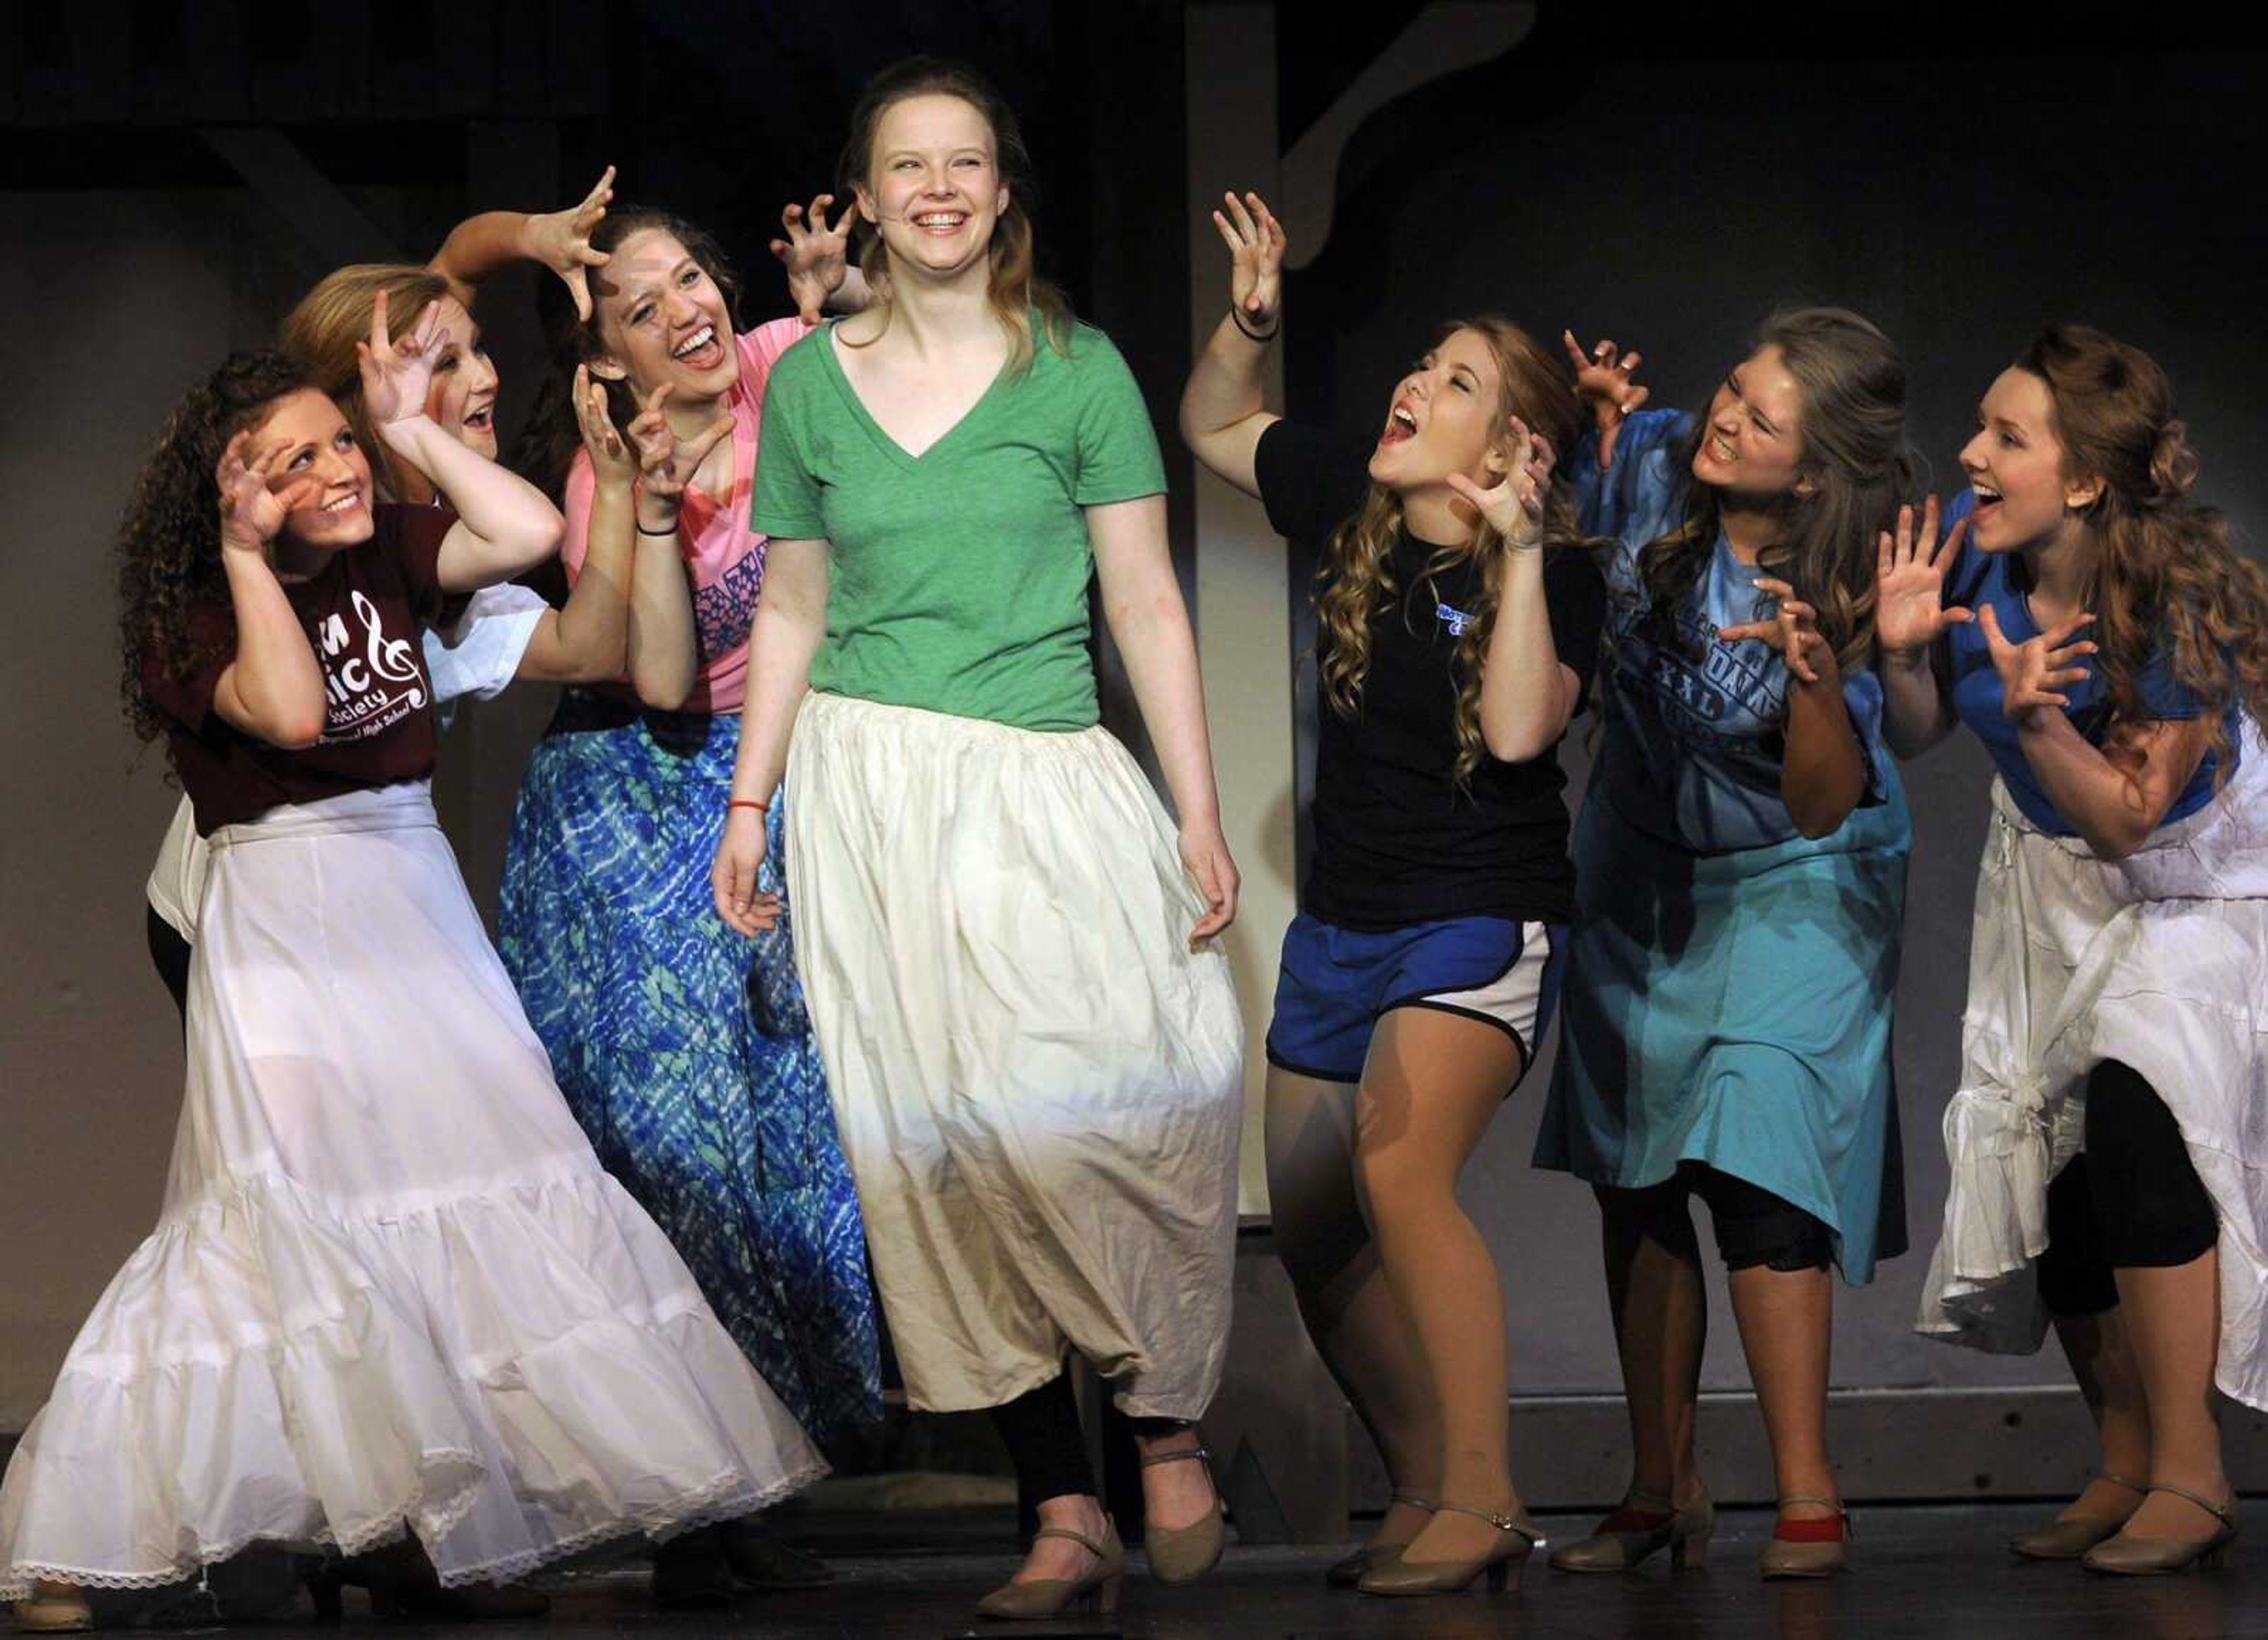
[787,694,1243,1418]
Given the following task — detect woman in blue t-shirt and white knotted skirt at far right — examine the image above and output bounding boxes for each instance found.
[1878,324,2268,1572]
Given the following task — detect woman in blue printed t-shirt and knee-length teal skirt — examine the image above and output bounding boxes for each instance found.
[1536,308,1912,1576]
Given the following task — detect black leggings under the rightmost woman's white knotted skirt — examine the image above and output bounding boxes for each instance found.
[2039,1059,2220,1316]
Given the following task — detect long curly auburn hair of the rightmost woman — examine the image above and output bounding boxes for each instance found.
[2016,324,2268,778]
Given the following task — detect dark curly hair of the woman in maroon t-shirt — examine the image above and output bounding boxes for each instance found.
[118,358,313,739]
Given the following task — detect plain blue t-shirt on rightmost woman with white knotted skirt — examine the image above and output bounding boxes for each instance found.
[1944,490,2238,837]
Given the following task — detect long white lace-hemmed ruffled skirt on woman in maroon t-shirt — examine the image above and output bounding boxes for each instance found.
[0,782,826,1599]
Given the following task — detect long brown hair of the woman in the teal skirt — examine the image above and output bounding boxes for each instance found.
[1637,308,1919,671]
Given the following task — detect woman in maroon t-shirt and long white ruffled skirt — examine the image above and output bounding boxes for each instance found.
[0,319,823,1631]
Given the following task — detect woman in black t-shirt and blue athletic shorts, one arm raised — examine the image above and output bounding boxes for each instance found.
[1182,195,1606,1595]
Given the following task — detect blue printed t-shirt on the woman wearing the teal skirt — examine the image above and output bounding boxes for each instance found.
[1574,410,1887,853]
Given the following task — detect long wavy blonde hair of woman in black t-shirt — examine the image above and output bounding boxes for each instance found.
[1315,313,1595,787]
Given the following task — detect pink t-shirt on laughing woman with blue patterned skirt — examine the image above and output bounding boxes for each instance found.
[560,320,810,712]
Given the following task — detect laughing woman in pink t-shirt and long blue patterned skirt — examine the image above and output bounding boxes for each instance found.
[497,195,882,1606]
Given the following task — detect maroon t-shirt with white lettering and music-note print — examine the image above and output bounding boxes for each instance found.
[143,506,456,837]
